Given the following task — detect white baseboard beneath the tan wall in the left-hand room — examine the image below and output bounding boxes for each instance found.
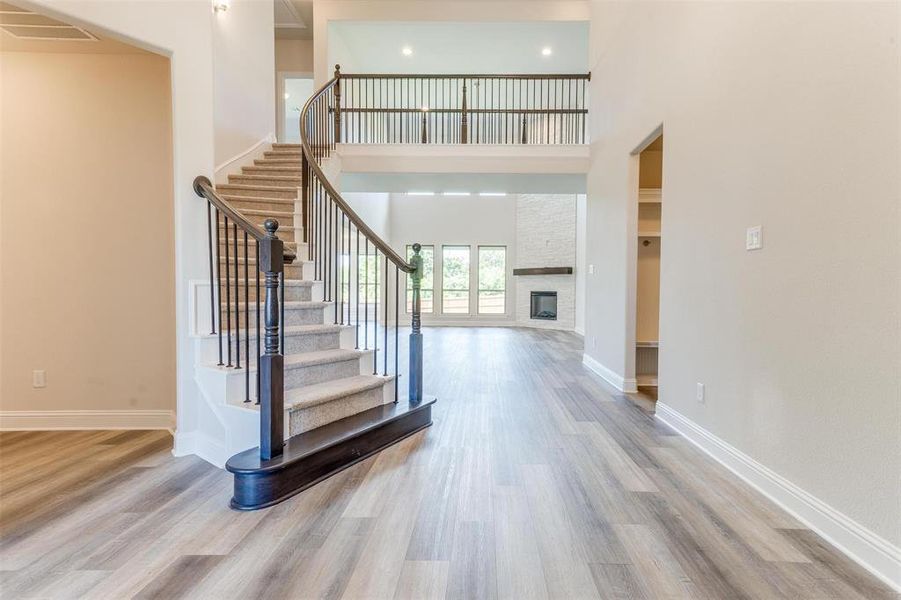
[0,410,175,431]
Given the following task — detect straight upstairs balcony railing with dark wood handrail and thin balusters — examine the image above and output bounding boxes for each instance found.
[329,65,591,144]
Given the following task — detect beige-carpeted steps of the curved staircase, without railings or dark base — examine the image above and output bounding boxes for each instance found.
[216,144,394,438]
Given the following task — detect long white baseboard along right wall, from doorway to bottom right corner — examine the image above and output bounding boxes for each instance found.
[657,402,901,591]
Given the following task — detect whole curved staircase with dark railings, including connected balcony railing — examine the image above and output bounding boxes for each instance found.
[194,67,590,510]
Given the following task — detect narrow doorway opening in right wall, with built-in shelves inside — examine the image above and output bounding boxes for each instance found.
[635,134,663,400]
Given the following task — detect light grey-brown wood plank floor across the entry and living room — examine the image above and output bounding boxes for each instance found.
[0,328,894,600]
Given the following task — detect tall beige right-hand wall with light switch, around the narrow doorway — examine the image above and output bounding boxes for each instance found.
[585,2,901,546]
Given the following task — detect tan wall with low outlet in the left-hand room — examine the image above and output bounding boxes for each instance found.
[0,52,176,418]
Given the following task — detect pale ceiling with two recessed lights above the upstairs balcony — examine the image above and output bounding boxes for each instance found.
[328,21,588,73]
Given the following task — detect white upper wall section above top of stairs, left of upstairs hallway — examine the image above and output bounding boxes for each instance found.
[213,0,276,165]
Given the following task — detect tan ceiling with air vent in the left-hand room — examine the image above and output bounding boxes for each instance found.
[0,2,145,54]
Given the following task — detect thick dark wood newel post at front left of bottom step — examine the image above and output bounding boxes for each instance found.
[259,219,285,460]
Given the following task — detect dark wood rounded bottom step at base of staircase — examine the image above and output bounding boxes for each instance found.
[225,397,436,510]
